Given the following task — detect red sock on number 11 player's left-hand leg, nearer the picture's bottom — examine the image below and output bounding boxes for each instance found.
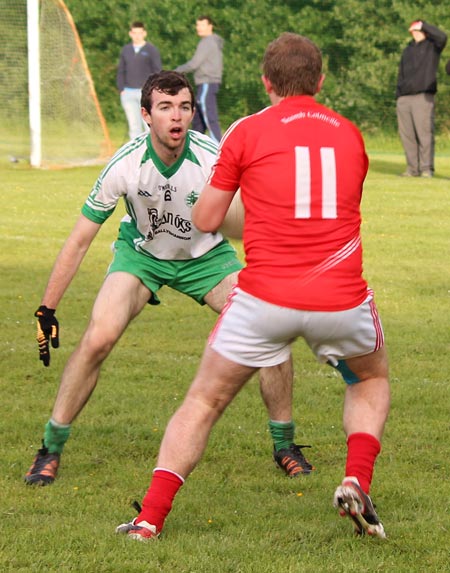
[136,469,183,533]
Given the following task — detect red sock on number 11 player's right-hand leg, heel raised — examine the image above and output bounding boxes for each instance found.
[345,432,381,494]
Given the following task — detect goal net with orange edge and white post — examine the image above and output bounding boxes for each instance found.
[0,0,112,167]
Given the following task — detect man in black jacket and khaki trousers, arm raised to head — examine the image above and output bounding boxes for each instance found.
[396,20,447,177]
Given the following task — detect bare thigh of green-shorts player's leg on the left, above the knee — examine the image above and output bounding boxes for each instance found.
[90,272,150,339]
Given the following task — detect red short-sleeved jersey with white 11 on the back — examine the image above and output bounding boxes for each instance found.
[208,96,368,311]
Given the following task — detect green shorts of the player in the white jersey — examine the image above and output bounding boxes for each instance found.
[108,238,243,305]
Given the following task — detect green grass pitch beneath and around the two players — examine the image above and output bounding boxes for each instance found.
[0,140,450,573]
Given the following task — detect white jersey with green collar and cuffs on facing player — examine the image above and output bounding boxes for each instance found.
[82,131,224,260]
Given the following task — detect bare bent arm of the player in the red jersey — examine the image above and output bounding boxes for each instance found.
[192,184,236,233]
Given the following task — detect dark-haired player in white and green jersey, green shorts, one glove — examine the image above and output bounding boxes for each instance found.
[25,71,312,485]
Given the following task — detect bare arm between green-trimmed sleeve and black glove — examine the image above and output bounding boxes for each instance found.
[41,215,101,308]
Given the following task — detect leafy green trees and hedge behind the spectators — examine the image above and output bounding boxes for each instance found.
[66,0,450,133]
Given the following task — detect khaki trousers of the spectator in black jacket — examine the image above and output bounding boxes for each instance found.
[397,93,434,175]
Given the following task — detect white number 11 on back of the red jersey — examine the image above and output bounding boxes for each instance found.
[295,147,337,219]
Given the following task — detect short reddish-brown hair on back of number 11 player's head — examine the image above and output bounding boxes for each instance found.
[262,32,322,97]
